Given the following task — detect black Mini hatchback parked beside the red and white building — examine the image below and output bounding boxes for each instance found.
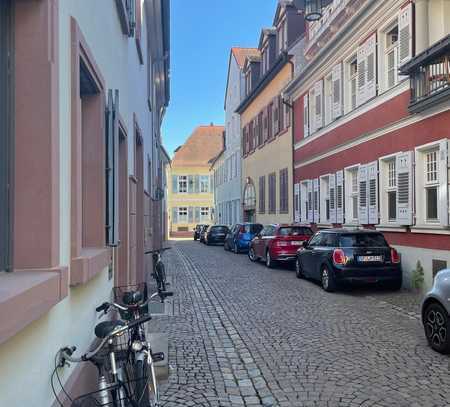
[295,229,402,291]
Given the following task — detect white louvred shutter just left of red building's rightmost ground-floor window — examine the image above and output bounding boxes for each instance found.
[395,151,413,225]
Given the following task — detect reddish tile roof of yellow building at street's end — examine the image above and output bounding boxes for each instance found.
[172,125,225,168]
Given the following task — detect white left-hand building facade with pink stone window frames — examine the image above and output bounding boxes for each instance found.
[0,0,170,407]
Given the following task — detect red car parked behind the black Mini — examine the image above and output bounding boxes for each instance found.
[248,224,313,268]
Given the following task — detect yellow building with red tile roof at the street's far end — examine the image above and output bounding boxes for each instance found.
[167,125,224,237]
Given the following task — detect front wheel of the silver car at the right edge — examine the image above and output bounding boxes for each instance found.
[423,303,450,354]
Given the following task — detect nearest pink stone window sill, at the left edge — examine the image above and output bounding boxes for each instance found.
[0,267,68,344]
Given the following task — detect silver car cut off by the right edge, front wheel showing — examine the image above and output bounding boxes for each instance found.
[422,269,450,354]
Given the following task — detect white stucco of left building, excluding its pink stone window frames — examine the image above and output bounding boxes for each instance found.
[0,0,159,407]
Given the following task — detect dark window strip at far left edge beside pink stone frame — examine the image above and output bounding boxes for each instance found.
[0,1,13,271]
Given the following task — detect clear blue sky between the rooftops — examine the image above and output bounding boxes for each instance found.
[162,0,277,156]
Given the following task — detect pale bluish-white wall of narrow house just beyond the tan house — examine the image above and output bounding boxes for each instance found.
[214,55,244,224]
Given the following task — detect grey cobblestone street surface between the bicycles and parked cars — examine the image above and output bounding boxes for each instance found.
[151,242,450,407]
